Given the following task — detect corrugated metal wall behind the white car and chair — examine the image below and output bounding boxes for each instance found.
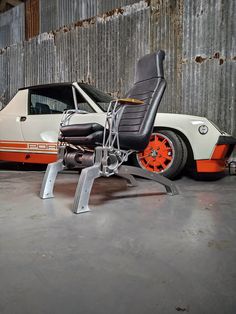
[0,0,236,136]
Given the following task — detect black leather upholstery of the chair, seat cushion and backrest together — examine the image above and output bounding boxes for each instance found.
[59,50,166,151]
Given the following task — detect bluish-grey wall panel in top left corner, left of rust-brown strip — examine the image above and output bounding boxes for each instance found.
[0,4,25,49]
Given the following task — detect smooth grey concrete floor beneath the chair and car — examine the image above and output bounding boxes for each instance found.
[0,169,236,314]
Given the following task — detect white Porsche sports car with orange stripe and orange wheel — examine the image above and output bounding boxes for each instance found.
[0,82,236,179]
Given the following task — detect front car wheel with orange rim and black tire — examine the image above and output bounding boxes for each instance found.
[132,129,188,179]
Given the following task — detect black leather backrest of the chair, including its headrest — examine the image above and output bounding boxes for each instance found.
[116,50,166,150]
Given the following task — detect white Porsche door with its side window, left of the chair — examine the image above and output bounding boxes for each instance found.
[21,84,100,147]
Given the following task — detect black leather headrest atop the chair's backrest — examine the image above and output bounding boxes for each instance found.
[135,50,165,83]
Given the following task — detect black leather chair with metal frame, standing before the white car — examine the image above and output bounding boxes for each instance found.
[40,50,178,213]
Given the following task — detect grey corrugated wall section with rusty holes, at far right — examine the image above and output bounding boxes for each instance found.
[182,0,236,135]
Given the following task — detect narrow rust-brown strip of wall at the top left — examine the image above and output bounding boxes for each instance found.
[25,0,39,40]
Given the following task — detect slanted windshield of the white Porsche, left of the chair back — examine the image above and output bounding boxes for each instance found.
[78,83,114,111]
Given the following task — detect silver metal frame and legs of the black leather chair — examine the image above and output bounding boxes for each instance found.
[40,100,178,214]
